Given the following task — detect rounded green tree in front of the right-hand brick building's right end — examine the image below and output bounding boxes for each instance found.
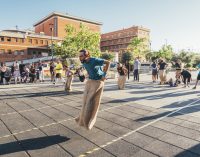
[128,37,149,57]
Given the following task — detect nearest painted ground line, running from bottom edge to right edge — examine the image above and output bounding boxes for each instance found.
[79,99,200,157]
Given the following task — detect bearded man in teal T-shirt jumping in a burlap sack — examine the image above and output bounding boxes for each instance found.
[75,50,110,130]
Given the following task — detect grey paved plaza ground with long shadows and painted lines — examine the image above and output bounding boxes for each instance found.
[0,74,200,157]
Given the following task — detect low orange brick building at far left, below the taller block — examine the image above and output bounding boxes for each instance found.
[0,30,61,62]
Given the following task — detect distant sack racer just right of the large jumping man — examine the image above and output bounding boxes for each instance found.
[117,63,128,89]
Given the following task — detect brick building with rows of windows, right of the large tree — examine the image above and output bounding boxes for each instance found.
[100,26,150,56]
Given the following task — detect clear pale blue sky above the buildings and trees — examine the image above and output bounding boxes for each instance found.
[0,0,200,51]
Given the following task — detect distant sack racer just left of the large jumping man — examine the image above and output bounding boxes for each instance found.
[65,66,74,92]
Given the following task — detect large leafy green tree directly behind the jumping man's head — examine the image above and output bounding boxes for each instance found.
[55,23,100,59]
